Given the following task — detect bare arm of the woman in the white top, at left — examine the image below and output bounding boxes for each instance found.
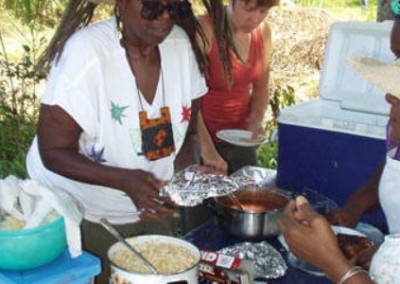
[38,105,174,220]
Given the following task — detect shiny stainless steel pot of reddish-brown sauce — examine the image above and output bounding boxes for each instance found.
[209,187,292,241]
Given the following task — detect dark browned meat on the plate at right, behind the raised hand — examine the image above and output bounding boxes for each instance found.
[337,233,373,259]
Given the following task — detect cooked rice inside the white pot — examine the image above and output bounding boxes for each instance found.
[111,241,198,274]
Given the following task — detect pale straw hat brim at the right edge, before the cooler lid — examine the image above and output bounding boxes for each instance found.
[350,57,400,99]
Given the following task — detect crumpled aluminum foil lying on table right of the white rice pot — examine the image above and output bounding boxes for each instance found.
[219,241,287,279]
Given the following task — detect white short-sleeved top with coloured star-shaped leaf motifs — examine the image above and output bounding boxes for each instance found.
[27,18,207,224]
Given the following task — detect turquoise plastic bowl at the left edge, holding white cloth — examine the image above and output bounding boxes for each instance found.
[0,217,67,270]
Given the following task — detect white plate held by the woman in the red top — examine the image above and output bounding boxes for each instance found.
[215,129,267,147]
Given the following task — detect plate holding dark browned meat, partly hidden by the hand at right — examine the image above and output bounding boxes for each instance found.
[278,222,384,276]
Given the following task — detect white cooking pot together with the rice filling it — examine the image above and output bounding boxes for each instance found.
[107,235,200,284]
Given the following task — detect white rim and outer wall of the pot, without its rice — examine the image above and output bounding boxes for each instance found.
[107,235,200,284]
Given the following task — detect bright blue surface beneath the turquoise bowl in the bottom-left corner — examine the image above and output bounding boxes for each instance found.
[0,250,101,284]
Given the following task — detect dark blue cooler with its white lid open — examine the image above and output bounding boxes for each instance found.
[277,21,395,231]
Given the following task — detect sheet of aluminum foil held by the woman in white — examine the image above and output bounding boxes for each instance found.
[160,165,255,206]
